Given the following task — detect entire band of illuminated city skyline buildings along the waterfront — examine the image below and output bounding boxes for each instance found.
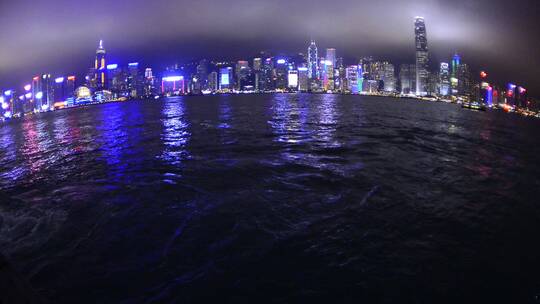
[0,17,538,119]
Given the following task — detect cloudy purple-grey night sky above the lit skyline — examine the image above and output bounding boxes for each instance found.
[0,0,540,96]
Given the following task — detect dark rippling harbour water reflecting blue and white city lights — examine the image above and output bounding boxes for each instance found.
[0,95,540,303]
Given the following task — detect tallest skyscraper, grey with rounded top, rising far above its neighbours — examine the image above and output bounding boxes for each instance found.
[414,17,429,96]
